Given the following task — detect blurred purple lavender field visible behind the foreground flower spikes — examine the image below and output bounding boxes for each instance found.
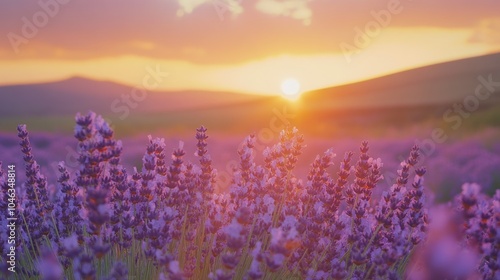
[0,123,500,202]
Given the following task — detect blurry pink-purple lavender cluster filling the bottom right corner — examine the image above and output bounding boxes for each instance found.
[410,184,500,279]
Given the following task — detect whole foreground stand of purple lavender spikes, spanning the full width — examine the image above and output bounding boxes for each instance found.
[0,113,500,279]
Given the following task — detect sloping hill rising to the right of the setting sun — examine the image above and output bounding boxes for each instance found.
[302,53,500,110]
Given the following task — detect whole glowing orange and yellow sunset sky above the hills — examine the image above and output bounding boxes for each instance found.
[0,0,500,94]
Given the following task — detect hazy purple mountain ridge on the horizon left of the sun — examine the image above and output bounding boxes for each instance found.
[0,77,265,116]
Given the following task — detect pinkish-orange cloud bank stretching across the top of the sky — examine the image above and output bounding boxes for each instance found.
[0,0,500,64]
